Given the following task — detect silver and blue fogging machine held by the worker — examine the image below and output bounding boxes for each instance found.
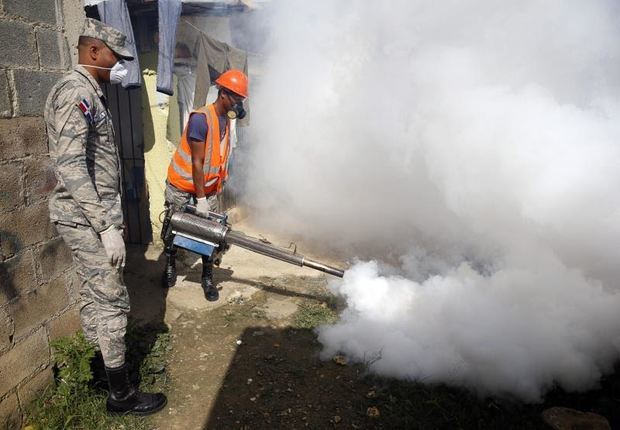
[170,212,344,278]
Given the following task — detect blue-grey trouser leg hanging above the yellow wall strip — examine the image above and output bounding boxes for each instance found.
[157,0,181,96]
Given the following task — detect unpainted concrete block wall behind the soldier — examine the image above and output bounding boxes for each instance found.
[0,0,85,429]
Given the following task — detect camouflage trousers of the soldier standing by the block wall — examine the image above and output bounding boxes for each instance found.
[56,223,129,367]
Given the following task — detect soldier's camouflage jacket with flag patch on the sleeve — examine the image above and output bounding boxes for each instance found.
[45,66,123,232]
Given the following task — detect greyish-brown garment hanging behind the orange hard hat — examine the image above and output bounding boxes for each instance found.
[194,32,249,126]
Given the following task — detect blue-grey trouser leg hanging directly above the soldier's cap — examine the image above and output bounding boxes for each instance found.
[97,0,142,88]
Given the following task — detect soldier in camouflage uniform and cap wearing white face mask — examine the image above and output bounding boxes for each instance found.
[45,19,166,415]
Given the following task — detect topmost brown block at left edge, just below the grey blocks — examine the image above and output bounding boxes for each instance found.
[0,118,48,160]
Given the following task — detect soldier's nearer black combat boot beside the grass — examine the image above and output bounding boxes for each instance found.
[105,363,168,415]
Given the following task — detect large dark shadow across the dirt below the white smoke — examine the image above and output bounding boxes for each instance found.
[202,327,546,430]
